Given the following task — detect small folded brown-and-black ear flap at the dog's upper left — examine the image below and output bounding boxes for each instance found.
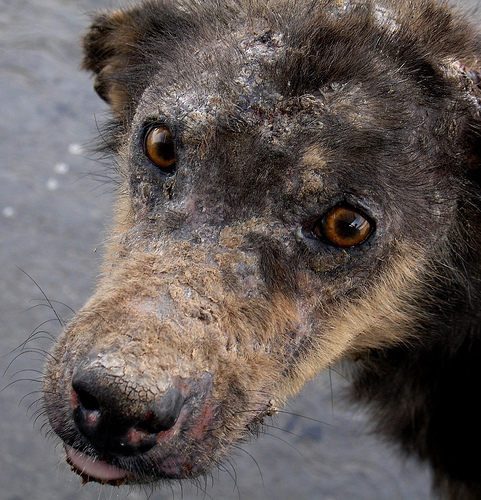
[82,11,140,115]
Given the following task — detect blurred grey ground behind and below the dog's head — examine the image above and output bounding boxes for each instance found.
[0,0,477,500]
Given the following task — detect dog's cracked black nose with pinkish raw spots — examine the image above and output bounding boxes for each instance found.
[72,369,184,456]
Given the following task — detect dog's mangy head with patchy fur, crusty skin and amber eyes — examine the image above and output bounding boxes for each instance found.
[45,1,478,483]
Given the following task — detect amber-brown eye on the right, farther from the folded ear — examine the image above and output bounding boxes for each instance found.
[313,206,373,247]
